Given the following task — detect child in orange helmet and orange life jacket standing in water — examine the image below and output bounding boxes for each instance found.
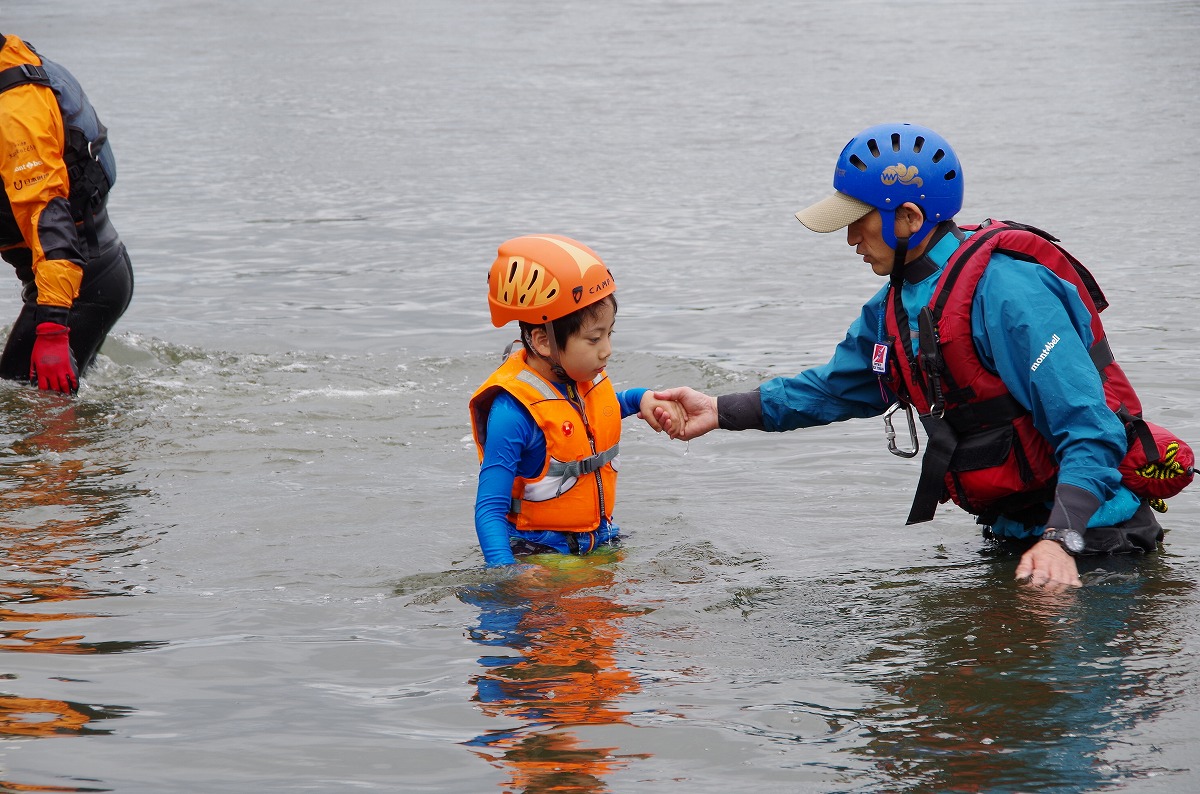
[470,234,684,566]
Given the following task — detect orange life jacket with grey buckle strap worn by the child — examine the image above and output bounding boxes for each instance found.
[470,350,620,533]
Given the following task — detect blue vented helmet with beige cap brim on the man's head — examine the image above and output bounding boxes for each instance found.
[796,124,962,248]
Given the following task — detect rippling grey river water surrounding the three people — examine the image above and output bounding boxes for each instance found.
[0,0,1200,794]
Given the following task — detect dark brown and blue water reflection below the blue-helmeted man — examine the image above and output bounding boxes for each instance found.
[852,555,1195,792]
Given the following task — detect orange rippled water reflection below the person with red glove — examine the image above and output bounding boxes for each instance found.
[0,389,158,748]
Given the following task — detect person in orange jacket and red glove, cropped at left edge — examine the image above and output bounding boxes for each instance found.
[0,35,133,392]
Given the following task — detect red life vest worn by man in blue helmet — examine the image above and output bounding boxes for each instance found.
[884,221,1148,524]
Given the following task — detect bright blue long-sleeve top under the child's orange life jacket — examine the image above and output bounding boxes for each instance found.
[475,383,647,566]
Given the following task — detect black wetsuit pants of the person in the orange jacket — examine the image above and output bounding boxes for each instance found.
[0,210,133,380]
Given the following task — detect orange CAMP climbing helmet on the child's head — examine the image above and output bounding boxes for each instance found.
[487,234,617,327]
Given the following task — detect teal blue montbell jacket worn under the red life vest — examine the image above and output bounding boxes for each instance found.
[719,225,1138,537]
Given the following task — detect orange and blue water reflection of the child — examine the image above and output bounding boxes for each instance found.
[460,555,647,794]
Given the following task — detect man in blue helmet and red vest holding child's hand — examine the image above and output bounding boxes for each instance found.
[658,124,1162,589]
